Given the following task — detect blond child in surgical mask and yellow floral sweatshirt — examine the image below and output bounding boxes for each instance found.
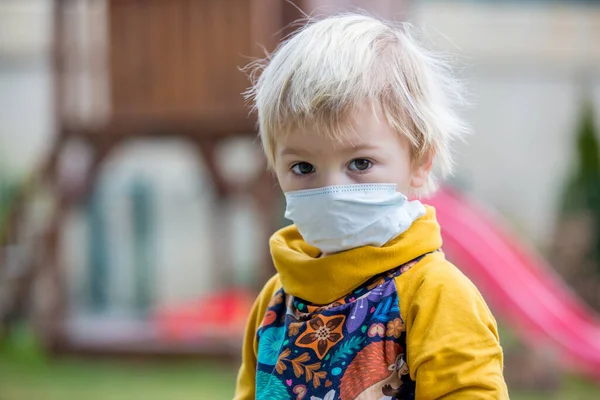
[235,14,508,400]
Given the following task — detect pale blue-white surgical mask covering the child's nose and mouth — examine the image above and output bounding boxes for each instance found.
[285,183,426,254]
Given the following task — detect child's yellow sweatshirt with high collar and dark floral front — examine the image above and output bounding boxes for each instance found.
[235,207,508,400]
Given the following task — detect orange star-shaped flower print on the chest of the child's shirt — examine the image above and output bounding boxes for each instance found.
[296,315,346,360]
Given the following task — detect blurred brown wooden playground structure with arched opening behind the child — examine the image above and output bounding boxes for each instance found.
[0,0,308,353]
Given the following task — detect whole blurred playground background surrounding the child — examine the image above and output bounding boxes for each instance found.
[0,0,600,400]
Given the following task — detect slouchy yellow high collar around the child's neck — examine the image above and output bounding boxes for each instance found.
[270,206,442,304]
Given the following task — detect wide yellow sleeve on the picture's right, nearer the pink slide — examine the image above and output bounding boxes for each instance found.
[396,253,508,400]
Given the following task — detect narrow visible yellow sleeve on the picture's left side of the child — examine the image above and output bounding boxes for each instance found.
[233,275,281,400]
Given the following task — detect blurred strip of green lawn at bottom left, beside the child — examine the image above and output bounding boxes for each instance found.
[0,360,234,400]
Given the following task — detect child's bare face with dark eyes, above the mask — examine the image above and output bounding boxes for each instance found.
[275,108,431,195]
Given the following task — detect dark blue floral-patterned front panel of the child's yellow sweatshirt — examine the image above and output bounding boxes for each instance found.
[256,256,434,400]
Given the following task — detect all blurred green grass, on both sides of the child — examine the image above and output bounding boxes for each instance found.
[0,326,600,400]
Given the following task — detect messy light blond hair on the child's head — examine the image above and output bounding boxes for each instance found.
[246,13,468,195]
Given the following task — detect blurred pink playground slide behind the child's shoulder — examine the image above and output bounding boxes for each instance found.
[427,189,600,381]
